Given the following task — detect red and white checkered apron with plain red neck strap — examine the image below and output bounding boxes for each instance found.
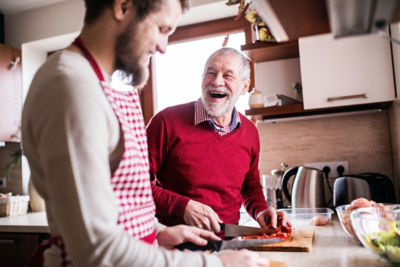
[74,38,157,244]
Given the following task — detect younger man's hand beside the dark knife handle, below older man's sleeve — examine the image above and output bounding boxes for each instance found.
[157,224,221,249]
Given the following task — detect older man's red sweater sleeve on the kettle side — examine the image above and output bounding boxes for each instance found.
[241,125,268,219]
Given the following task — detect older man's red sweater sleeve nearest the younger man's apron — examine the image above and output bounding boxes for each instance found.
[147,113,190,218]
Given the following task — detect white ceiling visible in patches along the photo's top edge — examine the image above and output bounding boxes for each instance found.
[0,0,222,15]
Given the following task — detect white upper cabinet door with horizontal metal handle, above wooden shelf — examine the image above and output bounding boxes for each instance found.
[299,34,395,109]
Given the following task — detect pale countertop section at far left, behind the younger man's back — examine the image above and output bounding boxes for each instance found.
[0,212,50,233]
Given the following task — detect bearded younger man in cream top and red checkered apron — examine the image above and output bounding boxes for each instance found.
[22,0,268,267]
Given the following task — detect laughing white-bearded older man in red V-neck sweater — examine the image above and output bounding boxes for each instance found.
[147,48,286,232]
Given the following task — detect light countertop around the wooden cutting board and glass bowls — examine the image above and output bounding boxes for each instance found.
[258,216,391,267]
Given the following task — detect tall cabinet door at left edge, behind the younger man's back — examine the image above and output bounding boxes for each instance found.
[0,44,22,141]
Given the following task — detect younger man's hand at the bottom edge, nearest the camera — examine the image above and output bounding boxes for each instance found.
[217,249,269,267]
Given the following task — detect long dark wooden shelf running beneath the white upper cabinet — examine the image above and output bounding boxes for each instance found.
[245,101,392,119]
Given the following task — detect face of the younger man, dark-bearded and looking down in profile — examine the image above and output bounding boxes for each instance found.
[115,0,182,87]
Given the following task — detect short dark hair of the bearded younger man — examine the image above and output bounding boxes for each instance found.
[84,0,189,24]
